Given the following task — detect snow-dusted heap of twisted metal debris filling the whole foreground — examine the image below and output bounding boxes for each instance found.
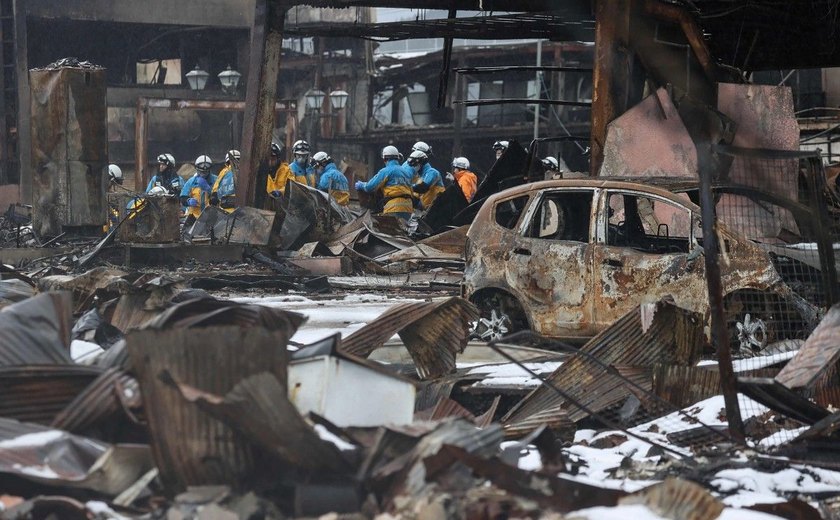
[0,274,840,520]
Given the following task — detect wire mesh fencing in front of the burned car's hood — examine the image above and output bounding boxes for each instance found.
[714,147,837,449]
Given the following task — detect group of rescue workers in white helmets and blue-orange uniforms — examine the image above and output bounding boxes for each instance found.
[108,140,557,226]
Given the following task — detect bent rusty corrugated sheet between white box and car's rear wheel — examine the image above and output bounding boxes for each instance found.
[339,297,478,379]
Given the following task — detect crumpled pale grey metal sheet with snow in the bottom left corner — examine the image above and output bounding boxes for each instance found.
[0,418,152,495]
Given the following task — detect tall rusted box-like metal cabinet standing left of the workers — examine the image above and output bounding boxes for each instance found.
[29,67,108,236]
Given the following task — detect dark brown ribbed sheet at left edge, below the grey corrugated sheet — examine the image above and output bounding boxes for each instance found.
[0,365,102,424]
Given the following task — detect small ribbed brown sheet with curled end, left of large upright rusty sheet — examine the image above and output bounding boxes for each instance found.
[52,368,140,432]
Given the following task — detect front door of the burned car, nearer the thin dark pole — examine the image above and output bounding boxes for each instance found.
[592,189,708,330]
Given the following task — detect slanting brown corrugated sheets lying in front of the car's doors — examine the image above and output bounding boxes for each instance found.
[502,301,704,429]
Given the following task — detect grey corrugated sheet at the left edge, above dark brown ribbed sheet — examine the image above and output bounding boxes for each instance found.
[0,292,73,366]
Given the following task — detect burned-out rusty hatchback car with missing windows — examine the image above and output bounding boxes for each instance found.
[463,178,817,350]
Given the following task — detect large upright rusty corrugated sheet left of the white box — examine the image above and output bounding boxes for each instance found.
[126,324,302,490]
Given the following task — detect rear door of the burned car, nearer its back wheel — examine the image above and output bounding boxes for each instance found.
[505,188,596,337]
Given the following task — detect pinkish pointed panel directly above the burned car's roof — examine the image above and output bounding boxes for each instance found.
[599,88,697,178]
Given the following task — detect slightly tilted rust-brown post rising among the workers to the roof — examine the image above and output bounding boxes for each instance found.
[236,0,289,206]
